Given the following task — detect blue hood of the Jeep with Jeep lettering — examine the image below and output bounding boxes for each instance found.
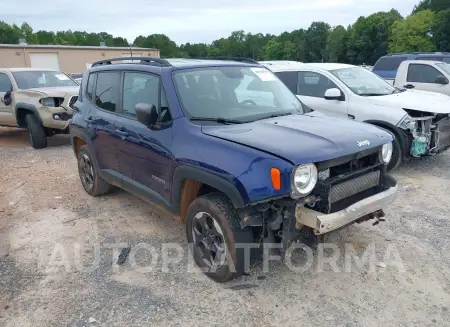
[202,112,392,164]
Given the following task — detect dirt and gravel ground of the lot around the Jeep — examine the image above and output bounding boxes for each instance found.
[0,129,450,327]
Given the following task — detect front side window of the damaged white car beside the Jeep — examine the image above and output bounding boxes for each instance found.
[297,72,338,98]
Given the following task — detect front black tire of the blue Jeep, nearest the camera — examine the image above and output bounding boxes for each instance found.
[186,193,260,282]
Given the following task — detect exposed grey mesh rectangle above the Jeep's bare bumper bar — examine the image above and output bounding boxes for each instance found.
[329,170,380,204]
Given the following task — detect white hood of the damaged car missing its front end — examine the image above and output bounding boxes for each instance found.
[369,90,450,114]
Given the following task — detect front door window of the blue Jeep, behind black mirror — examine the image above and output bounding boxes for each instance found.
[123,73,159,117]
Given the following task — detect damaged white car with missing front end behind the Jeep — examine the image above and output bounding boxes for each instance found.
[264,61,450,170]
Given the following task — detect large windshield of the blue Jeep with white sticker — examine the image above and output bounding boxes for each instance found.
[174,67,303,121]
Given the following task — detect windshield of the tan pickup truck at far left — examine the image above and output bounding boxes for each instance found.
[13,71,78,90]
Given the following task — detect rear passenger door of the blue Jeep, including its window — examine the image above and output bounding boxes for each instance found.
[83,71,121,174]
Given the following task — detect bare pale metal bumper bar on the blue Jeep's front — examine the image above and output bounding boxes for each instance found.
[295,186,397,235]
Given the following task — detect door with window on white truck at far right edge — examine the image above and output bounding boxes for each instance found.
[405,63,450,94]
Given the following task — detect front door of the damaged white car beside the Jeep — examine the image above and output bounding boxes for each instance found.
[297,71,348,118]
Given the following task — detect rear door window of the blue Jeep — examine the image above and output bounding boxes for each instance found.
[95,72,120,112]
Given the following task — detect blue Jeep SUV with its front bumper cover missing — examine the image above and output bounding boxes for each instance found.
[70,57,397,281]
